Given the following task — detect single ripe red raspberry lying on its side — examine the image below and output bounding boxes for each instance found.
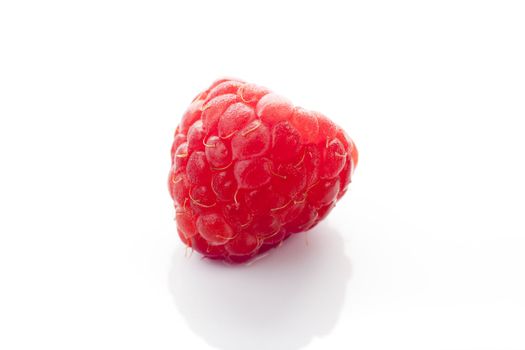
[169,79,358,263]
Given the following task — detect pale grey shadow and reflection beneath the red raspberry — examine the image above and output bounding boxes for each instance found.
[169,223,351,350]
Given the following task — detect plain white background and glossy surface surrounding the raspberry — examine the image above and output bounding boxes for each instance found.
[0,0,525,350]
